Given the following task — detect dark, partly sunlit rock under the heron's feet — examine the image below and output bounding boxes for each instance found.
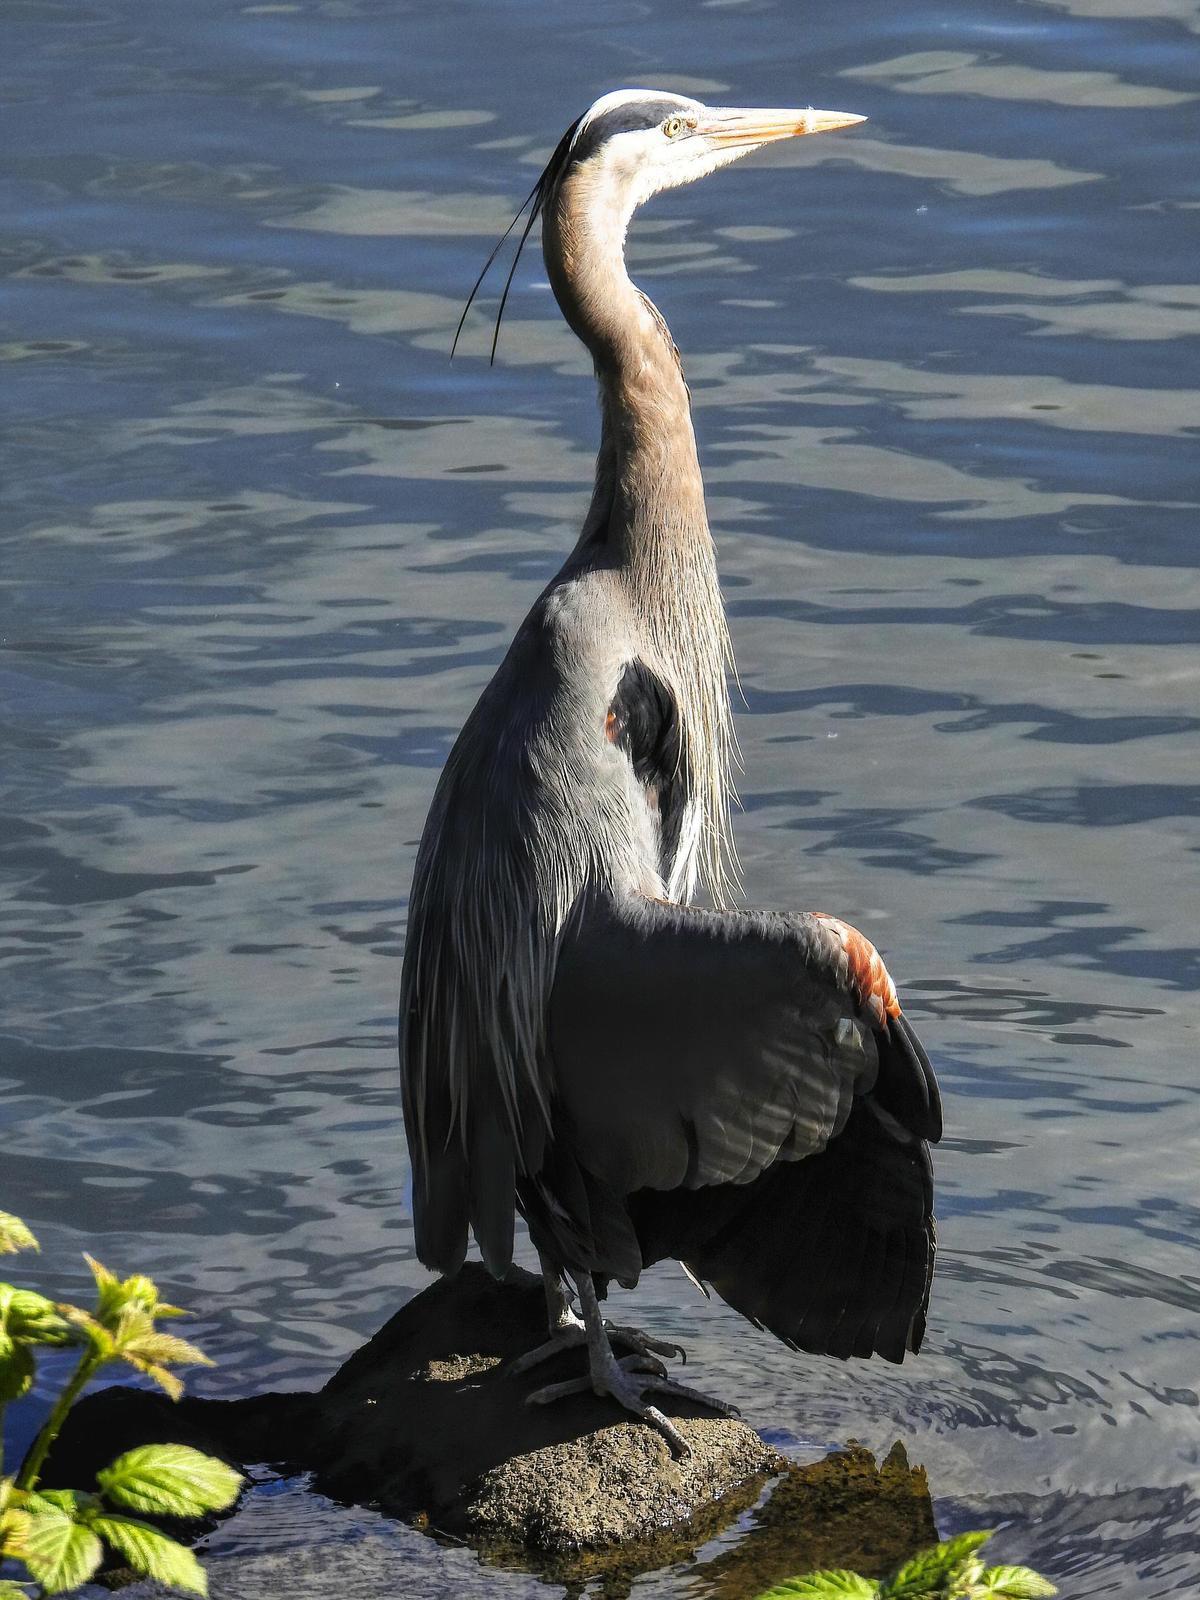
[46,1266,933,1595]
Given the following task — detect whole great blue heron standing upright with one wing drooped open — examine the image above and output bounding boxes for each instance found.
[400,90,941,1450]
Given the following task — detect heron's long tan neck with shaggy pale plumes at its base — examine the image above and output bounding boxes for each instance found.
[542,170,736,906]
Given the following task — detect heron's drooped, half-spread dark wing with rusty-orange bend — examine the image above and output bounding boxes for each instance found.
[534,896,941,1360]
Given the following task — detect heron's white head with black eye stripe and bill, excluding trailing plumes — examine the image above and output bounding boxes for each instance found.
[553,90,866,222]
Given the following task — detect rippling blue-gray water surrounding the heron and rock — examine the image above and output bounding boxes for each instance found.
[0,0,1200,1600]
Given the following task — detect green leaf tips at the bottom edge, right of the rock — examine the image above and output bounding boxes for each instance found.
[758,1531,1058,1600]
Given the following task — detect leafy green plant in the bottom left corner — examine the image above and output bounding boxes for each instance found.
[0,1211,243,1600]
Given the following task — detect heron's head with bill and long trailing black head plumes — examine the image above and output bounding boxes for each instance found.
[451,90,867,360]
